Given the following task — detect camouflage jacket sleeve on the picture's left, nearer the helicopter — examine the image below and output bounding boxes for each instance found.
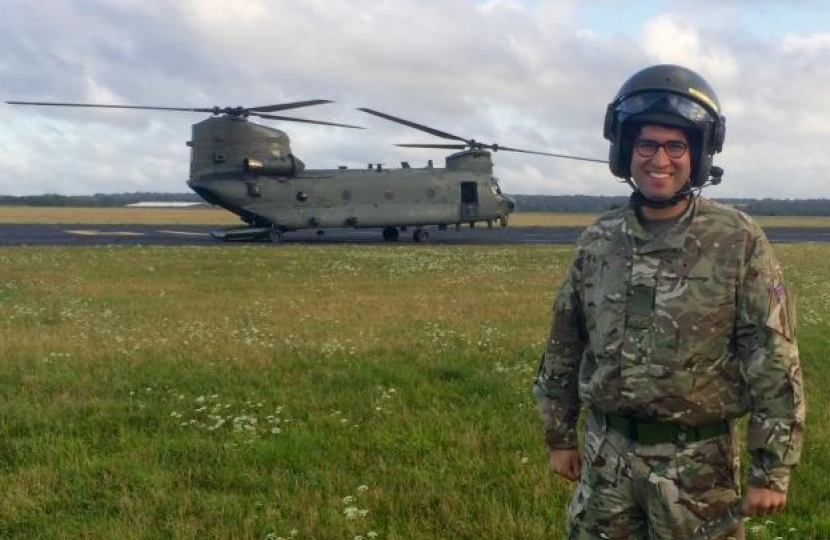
[533,253,586,450]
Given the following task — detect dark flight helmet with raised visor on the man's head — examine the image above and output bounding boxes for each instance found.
[604,64,726,187]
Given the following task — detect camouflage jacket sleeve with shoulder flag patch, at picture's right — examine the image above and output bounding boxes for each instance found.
[736,230,806,492]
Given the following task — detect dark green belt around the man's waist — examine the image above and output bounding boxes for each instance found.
[605,414,729,444]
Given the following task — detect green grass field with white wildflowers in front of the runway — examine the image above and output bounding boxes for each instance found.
[0,245,830,540]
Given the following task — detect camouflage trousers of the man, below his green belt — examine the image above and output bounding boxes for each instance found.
[565,413,744,540]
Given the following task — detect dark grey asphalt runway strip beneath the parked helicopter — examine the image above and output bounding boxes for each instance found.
[0,224,830,246]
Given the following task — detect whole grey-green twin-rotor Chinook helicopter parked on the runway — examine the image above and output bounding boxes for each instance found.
[6,100,607,243]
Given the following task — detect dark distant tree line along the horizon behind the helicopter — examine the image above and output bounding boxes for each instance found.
[0,192,830,216]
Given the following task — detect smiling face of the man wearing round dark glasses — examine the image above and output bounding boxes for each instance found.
[631,125,692,201]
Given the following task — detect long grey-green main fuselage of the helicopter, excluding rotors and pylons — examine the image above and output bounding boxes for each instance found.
[189,159,512,231]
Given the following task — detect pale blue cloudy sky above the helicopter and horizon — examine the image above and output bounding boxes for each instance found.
[0,0,830,198]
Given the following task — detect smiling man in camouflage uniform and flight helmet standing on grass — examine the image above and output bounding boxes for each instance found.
[534,65,805,540]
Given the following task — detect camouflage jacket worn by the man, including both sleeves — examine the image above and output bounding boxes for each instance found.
[534,198,805,490]
